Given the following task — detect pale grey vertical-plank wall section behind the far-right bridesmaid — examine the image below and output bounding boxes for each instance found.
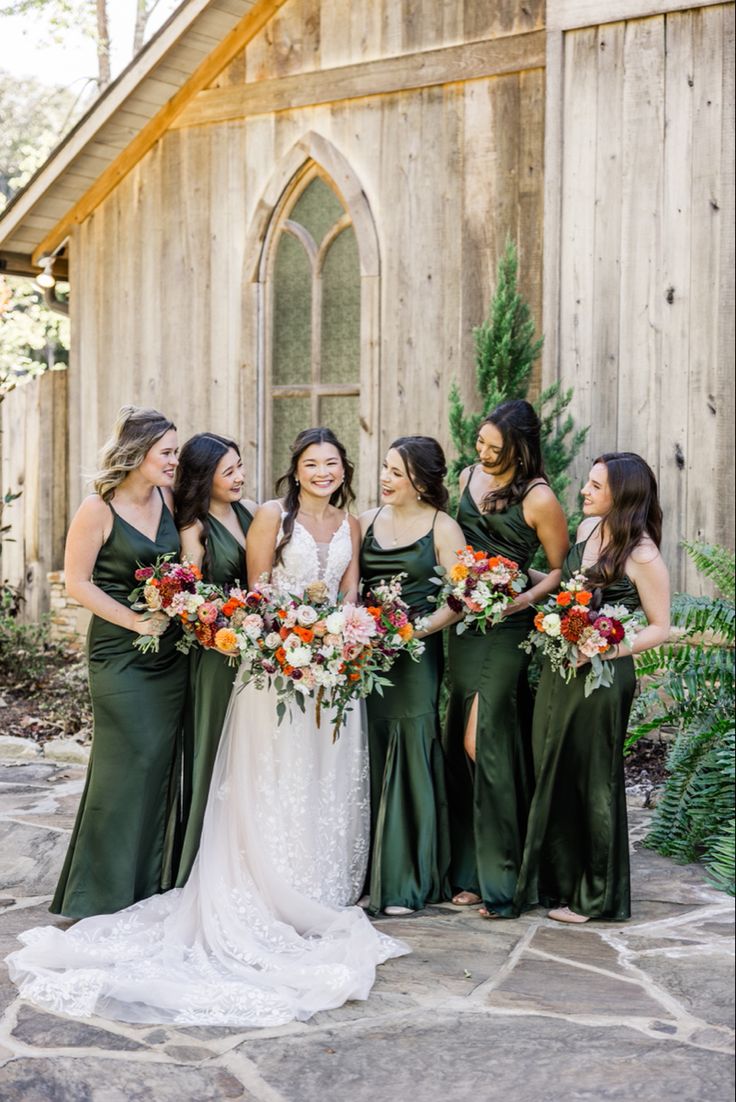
[544,4,734,592]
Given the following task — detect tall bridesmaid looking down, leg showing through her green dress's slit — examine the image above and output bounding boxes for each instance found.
[444,400,569,918]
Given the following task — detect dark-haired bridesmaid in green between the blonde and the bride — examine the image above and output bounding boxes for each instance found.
[174,432,258,887]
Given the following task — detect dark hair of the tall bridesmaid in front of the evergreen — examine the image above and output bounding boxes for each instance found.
[478,398,546,512]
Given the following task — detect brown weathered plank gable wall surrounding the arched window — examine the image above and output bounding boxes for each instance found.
[71,0,544,505]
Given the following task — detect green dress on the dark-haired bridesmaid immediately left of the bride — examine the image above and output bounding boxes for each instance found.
[176,501,253,887]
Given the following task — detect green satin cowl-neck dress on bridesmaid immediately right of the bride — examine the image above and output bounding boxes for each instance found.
[360,515,450,914]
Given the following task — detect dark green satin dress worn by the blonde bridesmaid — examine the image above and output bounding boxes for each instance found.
[50,499,187,918]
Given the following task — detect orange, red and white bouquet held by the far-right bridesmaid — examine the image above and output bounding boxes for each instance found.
[520,573,641,696]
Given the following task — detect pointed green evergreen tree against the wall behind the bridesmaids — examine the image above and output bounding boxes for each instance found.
[450,241,587,531]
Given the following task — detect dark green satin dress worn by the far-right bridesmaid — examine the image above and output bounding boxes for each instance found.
[517,543,640,920]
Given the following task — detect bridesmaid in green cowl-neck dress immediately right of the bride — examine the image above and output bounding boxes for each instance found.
[360,436,463,915]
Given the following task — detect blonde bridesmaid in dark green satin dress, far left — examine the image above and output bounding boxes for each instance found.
[51,407,187,918]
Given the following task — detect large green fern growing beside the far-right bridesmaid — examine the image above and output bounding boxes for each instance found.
[627,543,736,895]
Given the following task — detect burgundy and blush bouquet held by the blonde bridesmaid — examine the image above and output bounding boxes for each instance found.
[128,553,206,653]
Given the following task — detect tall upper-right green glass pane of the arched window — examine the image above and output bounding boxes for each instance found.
[320,226,360,382]
